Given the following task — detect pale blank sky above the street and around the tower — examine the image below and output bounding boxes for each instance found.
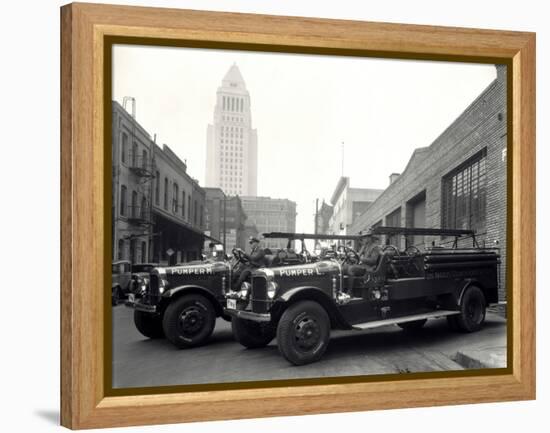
[113,45,496,232]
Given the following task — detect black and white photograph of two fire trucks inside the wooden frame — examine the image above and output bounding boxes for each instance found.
[111,44,508,389]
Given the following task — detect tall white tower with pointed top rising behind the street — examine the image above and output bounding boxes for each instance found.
[206,64,258,196]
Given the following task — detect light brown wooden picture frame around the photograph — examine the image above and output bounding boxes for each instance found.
[61,3,535,429]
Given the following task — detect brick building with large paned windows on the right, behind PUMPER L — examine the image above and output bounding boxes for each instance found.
[350,65,507,300]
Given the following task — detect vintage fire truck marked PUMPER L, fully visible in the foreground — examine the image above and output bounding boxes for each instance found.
[225,227,500,365]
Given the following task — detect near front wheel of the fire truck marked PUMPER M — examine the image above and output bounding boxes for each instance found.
[162,294,216,349]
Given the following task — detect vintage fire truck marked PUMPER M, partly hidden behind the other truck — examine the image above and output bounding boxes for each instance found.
[126,243,312,348]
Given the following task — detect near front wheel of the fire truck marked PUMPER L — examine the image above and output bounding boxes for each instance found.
[277,301,330,365]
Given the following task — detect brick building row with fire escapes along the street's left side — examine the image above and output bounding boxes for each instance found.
[111,98,205,264]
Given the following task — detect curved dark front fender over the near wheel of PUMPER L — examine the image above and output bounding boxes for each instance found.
[271,286,351,329]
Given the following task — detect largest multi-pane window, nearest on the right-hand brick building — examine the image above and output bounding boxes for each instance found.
[441,149,487,232]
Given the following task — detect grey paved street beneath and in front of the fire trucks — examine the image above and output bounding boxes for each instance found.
[113,305,506,388]
